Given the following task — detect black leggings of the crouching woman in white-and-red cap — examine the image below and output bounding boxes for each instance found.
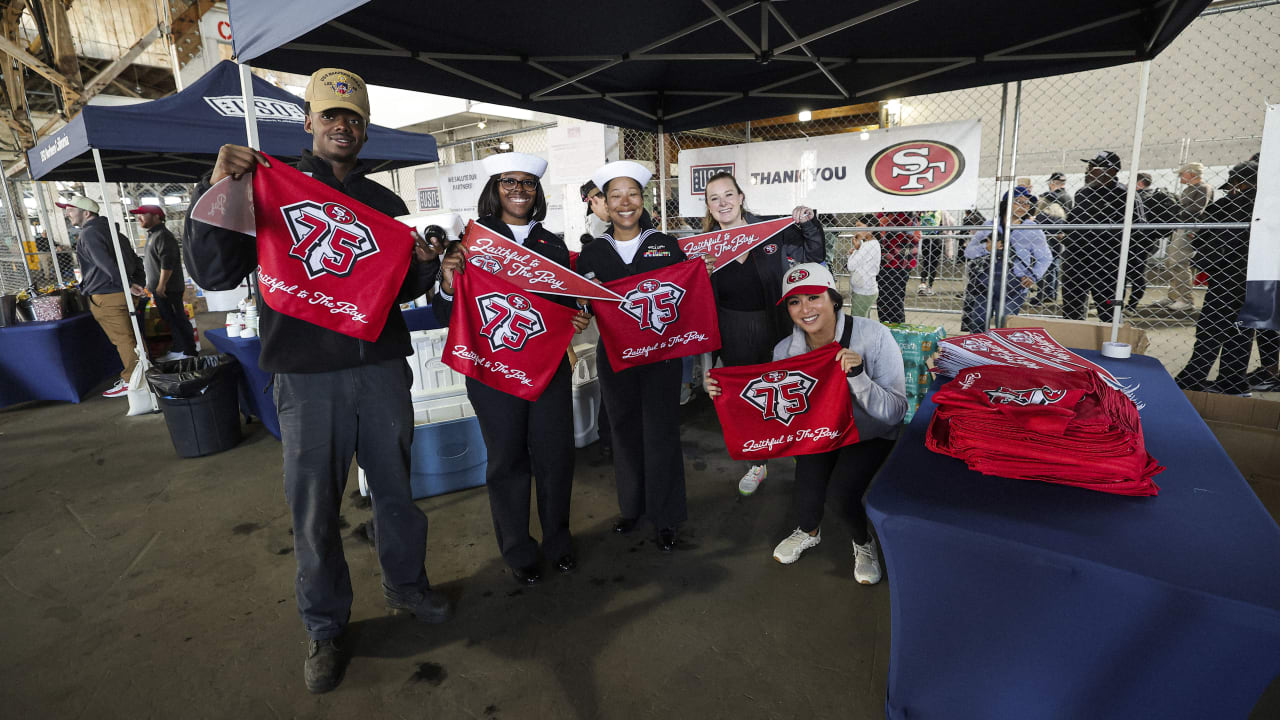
[791,438,893,544]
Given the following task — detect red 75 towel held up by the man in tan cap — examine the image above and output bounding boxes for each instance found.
[253,158,413,342]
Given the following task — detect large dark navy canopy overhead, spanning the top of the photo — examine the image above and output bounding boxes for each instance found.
[229,0,1208,132]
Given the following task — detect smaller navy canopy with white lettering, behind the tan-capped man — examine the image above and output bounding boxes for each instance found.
[27,60,436,182]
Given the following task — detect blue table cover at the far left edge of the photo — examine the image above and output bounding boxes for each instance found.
[0,313,123,407]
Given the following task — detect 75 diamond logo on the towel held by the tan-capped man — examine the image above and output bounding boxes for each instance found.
[280,200,378,279]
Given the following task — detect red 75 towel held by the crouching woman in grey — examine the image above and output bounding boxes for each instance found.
[710,342,858,460]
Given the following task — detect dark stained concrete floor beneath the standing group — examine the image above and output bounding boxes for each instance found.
[0,319,1280,720]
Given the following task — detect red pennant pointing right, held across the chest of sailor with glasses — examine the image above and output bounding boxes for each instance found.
[462,220,620,301]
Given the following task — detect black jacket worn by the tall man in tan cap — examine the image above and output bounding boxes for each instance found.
[182,151,439,373]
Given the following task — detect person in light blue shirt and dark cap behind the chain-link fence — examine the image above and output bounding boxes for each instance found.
[960,186,1053,333]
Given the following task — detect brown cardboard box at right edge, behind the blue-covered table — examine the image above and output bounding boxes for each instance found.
[1177,391,1280,523]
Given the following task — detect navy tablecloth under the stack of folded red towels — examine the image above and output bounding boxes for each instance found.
[867,352,1280,720]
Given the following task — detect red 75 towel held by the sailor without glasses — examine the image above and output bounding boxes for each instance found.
[591,260,719,370]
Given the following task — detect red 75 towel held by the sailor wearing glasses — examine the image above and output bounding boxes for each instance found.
[443,266,575,401]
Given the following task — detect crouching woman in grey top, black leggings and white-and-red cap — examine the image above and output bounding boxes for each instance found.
[707,263,906,585]
